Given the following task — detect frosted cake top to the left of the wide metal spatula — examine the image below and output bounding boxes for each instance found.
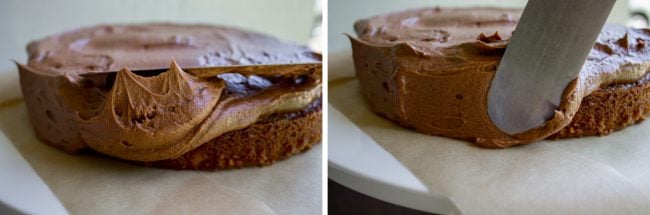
[354,7,521,49]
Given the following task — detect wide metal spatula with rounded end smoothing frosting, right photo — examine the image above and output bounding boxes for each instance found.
[488,0,615,134]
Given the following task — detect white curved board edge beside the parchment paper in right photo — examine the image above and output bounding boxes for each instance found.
[328,105,456,214]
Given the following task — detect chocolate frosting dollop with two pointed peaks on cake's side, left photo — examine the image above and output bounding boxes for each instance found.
[81,61,224,159]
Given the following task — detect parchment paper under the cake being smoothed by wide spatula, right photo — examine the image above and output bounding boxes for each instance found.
[329,52,650,214]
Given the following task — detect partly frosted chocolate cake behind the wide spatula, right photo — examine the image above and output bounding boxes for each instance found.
[350,7,650,148]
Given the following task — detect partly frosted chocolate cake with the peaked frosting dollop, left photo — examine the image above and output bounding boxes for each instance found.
[17,24,322,170]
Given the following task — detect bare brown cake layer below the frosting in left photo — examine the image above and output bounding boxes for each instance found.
[143,99,322,170]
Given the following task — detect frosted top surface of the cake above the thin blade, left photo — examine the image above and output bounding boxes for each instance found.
[27,24,321,74]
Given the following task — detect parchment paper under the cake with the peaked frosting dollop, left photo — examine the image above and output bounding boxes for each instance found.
[0,73,322,214]
